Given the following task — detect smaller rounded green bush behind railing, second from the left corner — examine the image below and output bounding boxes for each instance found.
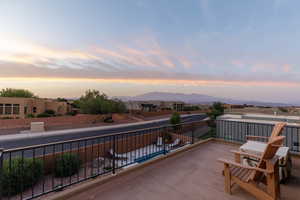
[54,153,81,177]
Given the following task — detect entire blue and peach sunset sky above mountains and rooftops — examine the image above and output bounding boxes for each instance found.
[0,0,300,103]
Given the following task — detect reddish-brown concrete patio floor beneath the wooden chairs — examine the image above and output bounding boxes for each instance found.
[62,142,300,200]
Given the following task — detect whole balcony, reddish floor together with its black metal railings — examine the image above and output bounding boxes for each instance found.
[0,120,300,200]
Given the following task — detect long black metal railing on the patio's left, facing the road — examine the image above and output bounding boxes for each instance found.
[0,121,205,200]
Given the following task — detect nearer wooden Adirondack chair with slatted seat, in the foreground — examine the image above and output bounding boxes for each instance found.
[218,136,285,200]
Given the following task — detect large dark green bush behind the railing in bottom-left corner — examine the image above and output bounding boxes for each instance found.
[1,157,43,196]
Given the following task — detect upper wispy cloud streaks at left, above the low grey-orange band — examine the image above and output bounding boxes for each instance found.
[0,34,191,70]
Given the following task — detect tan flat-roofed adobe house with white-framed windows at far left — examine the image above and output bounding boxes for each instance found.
[0,97,70,118]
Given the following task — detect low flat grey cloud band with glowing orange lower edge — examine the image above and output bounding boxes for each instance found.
[0,60,300,87]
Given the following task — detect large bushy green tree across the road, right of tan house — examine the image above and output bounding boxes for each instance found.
[74,90,126,114]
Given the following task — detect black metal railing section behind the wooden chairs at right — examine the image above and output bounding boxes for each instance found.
[216,120,300,153]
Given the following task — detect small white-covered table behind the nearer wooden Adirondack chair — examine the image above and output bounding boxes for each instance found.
[240,141,292,182]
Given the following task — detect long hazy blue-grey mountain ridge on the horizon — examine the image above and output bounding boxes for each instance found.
[115,92,291,106]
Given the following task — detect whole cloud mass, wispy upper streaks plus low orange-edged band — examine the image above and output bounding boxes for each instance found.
[0,36,299,86]
